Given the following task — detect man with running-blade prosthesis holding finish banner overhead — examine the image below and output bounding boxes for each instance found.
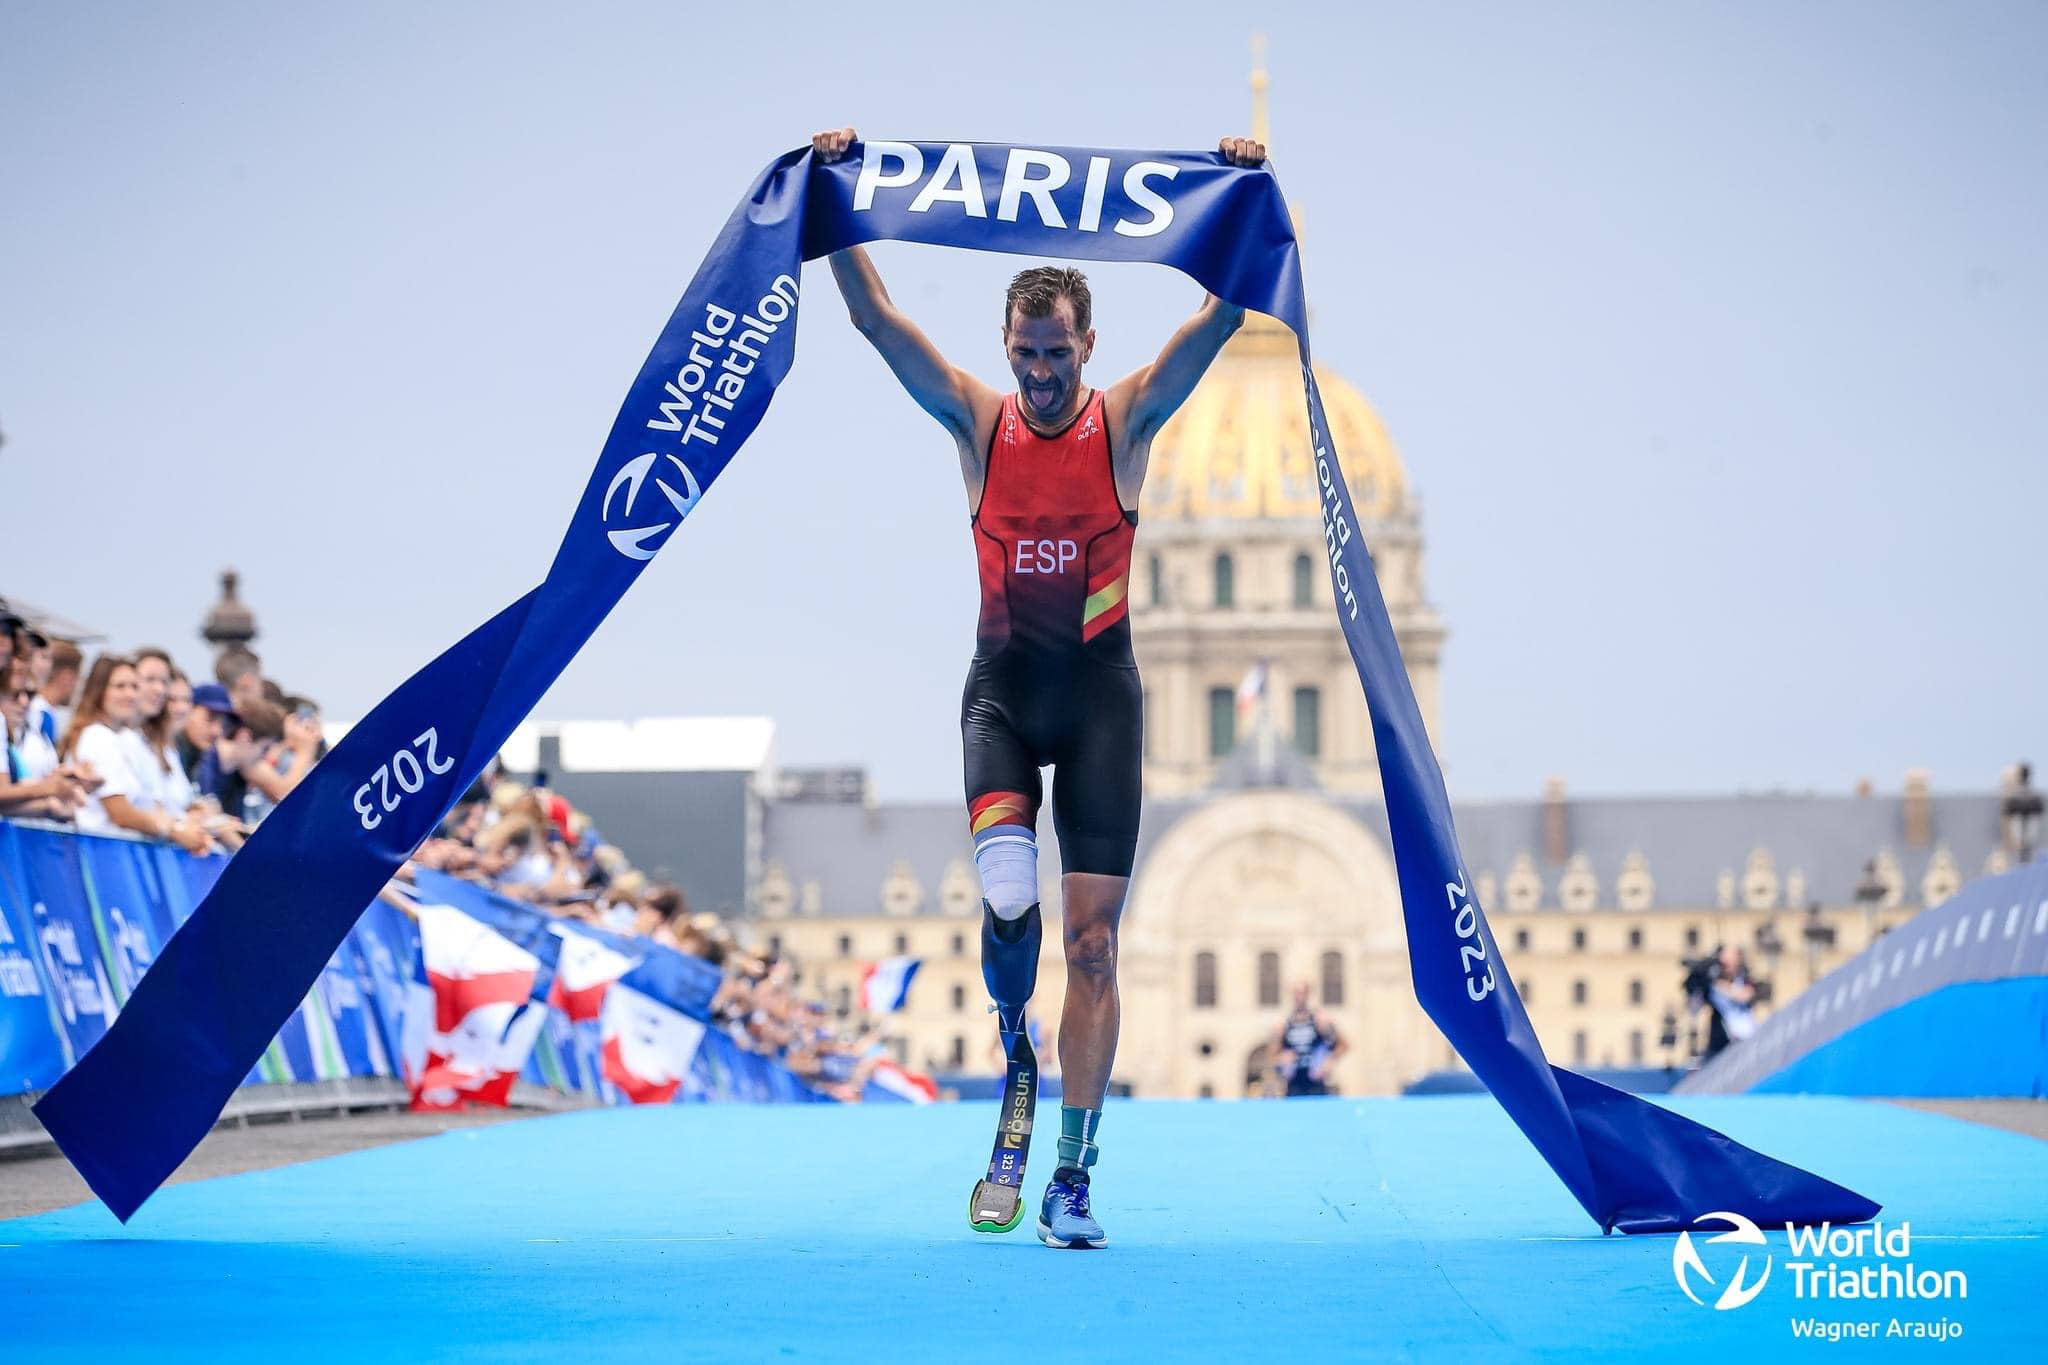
[811,129,1266,1246]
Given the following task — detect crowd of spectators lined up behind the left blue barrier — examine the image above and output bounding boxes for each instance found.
[0,598,883,1099]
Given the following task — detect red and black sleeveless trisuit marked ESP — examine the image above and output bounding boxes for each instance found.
[961,389,1145,876]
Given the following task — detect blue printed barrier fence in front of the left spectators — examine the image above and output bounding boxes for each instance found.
[0,821,856,1103]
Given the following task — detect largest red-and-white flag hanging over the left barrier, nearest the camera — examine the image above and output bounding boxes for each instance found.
[406,905,547,1109]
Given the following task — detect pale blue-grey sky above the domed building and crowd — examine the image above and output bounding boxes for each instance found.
[0,0,2048,798]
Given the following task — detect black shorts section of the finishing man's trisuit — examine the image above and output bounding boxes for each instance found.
[961,647,1145,876]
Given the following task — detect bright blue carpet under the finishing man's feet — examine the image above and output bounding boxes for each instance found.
[0,1097,2048,1365]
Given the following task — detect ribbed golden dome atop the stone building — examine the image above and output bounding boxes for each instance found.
[1139,313,1407,520]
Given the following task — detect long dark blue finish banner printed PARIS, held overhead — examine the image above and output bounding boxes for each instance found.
[37,141,1876,1232]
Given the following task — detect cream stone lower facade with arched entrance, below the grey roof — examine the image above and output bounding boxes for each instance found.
[756,790,1941,1097]
